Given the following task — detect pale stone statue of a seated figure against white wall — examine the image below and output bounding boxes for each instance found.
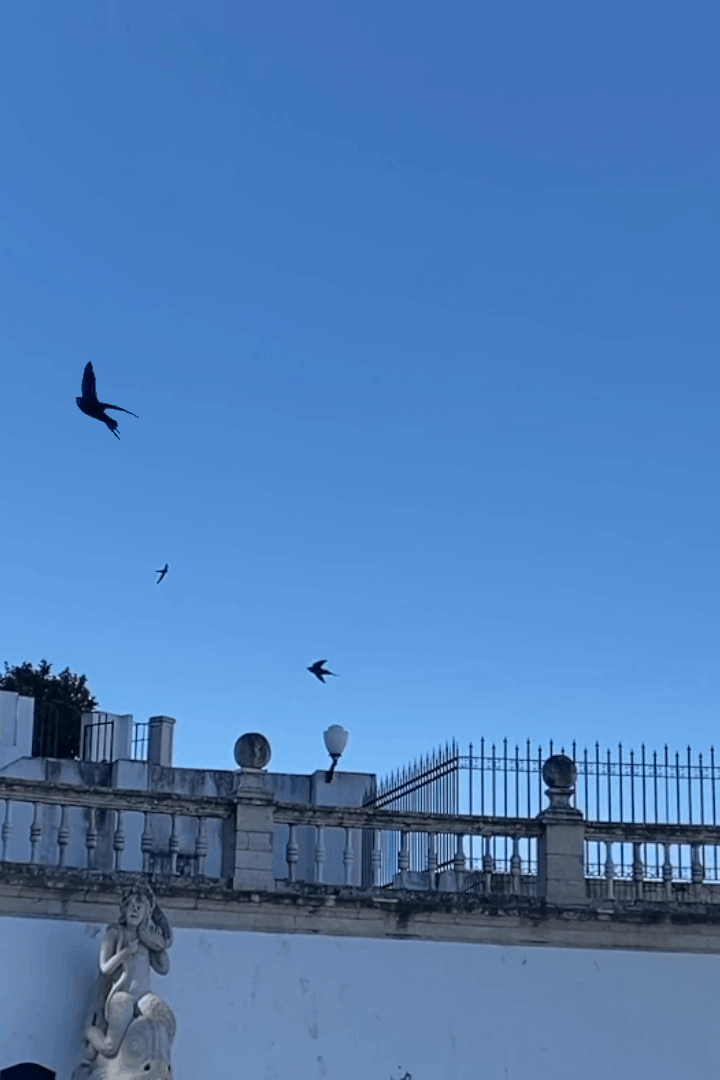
[72,886,175,1080]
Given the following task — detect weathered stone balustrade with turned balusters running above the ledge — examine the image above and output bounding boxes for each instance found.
[0,758,720,906]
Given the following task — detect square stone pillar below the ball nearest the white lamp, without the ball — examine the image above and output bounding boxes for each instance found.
[232,769,275,891]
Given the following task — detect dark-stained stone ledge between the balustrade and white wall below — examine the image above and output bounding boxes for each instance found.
[0,865,720,954]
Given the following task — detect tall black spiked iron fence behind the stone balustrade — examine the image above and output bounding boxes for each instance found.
[367,739,720,880]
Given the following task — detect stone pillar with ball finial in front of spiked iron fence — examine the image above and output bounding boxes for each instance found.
[538,754,587,906]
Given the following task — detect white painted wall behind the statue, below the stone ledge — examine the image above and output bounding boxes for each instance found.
[0,917,720,1080]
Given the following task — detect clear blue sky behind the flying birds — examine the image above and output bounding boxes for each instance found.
[0,0,720,774]
